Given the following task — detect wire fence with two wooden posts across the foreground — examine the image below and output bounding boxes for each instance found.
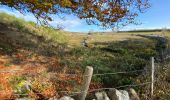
[0,58,155,100]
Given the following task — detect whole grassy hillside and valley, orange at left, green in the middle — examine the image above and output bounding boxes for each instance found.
[0,13,170,100]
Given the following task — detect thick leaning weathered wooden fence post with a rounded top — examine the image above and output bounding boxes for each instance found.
[80,66,93,100]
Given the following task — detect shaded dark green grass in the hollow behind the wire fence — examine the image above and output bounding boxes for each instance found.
[63,39,158,87]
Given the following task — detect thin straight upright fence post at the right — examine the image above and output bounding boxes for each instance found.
[151,57,155,100]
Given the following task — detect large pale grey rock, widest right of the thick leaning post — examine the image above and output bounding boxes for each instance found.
[108,89,130,100]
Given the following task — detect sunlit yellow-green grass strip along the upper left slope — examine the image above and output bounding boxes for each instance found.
[0,12,68,43]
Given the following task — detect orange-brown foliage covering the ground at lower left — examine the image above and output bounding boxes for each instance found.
[0,49,82,100]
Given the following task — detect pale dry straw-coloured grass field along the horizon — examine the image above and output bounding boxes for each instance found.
[68,32,166,47]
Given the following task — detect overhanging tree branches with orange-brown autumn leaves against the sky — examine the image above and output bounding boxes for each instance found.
[0,0,149,28]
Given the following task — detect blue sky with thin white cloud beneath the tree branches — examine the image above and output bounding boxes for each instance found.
[0,0,170,32]
